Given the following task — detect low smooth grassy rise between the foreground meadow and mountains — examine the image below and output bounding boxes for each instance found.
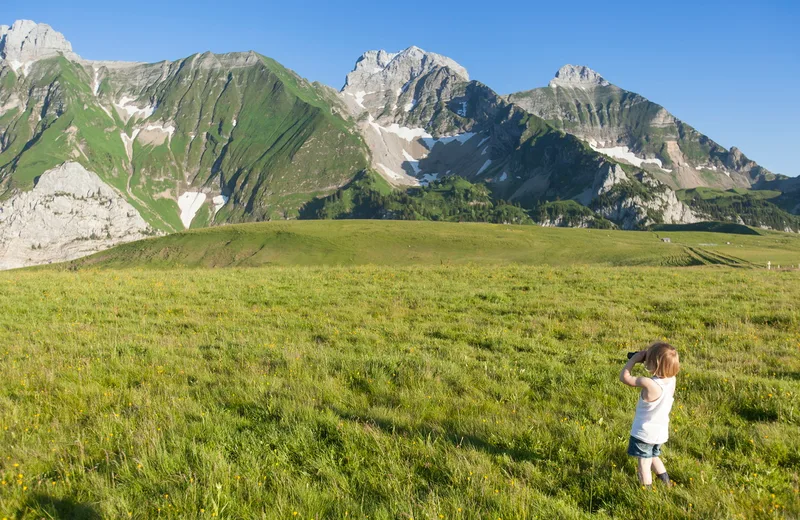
[68,220,800,268]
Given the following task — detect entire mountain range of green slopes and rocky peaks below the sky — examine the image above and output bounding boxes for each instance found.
[0,21,800,268]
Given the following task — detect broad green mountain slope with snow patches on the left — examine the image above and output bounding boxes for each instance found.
[0,53,368,231]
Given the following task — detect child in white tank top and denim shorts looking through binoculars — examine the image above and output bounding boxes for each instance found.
[619,341,681,486]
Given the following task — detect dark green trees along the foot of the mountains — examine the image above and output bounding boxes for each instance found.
[300,171,800,231]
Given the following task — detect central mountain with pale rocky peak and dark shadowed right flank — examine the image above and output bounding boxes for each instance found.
[341,47,624,207]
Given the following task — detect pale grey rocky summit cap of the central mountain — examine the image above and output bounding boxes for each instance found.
[342,46,469,92]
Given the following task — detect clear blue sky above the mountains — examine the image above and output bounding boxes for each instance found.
[6,0,800,175]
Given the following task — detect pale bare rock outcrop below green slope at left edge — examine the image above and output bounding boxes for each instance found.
[0,162,154,269]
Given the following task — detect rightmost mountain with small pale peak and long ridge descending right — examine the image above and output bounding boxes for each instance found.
[507,65,772,189]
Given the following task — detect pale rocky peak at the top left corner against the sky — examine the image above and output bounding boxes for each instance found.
[0,20,77,63]
